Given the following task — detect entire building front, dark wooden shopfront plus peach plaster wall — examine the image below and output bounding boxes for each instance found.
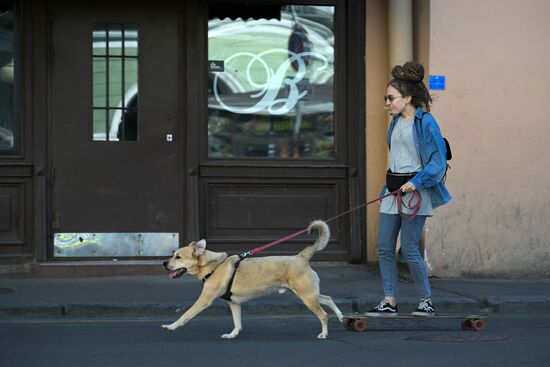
[0,0,550,276]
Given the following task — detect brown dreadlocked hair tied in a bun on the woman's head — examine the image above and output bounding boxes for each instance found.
[388,61,432,111]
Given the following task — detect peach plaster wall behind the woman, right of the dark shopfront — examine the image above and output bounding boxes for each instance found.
[366,0,550,277]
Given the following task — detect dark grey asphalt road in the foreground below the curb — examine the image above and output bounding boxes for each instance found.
[0,314,550,367]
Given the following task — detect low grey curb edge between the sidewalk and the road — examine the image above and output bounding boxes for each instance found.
[0,296,550,320]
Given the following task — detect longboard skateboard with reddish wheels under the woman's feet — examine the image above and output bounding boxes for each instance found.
[342,313,487,332]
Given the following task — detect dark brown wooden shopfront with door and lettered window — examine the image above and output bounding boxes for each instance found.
[0,0,365,274]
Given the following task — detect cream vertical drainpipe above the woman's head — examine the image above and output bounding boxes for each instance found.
[388,0,413,70]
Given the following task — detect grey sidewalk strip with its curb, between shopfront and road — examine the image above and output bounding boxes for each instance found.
[0,264,550,319]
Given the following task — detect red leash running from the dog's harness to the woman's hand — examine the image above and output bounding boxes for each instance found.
[239,189,422,259]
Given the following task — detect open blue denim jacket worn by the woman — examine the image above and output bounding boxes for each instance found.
[381,107,452,209]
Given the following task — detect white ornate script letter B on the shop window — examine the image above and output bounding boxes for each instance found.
[212,49,328,115]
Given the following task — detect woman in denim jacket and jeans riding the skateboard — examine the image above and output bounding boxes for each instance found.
[366,61,451,316]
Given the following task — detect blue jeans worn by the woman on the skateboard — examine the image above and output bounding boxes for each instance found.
[378,213,432,298]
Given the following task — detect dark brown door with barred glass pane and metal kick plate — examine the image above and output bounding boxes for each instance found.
[49,1,183,258]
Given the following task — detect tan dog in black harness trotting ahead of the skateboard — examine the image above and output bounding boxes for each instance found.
[162,220,342,339]
